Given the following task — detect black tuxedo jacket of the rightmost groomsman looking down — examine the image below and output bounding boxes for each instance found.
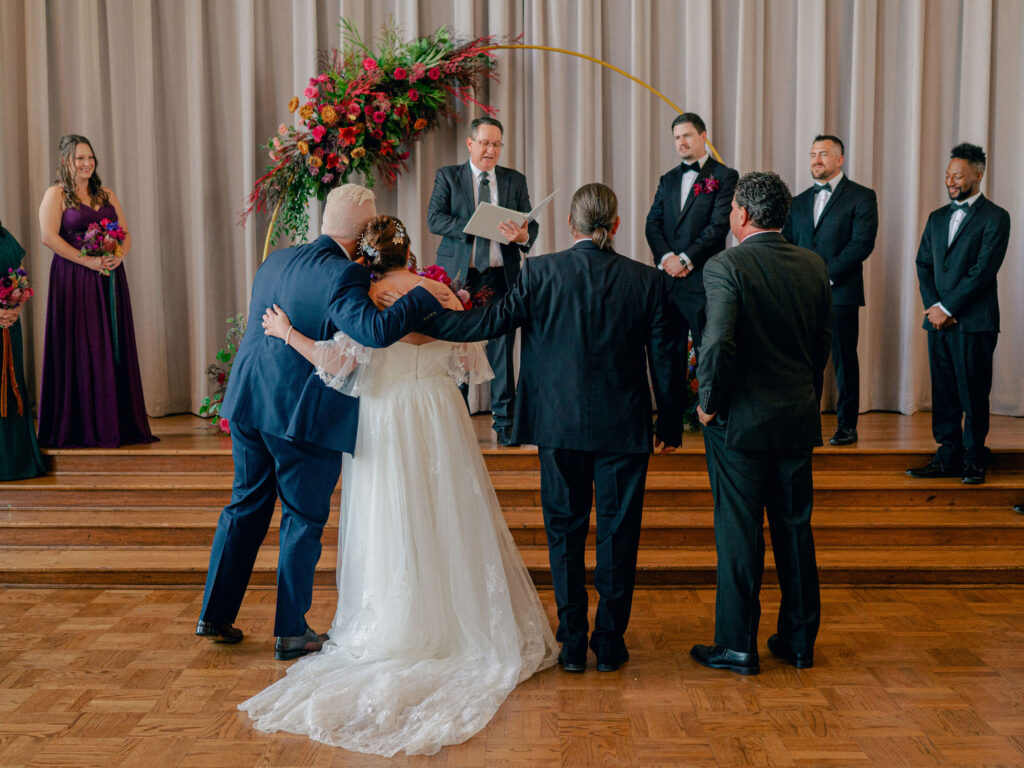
[918,195,1010,333]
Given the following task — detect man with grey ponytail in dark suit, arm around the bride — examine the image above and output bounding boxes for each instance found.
[423,183,682,672]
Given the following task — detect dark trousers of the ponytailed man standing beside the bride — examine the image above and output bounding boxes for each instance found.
[538,447,650,657]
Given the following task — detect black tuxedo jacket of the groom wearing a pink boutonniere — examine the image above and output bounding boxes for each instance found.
[644,157,739,291]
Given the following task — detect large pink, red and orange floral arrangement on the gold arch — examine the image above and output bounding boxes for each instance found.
[241,18,497,242]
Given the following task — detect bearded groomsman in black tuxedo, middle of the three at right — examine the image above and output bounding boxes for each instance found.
[782,134,879,445]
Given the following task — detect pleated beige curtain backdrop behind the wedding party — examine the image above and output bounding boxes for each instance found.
[0,0,1024,416]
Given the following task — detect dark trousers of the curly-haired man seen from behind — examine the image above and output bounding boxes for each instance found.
[703,425,821,653]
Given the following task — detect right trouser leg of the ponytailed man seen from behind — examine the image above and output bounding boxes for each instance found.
[590,454,650,659]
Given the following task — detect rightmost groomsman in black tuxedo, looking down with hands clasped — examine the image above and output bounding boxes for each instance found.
[907,143,1010,484]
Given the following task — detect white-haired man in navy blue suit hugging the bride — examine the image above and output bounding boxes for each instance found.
[196,184,440,660]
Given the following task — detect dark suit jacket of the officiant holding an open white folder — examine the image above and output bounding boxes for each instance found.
[427,161,540,286]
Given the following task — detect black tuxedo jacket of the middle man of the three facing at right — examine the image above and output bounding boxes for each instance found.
[782,175,879,306]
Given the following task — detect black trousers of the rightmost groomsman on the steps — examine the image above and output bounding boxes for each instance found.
[928,328,998,467]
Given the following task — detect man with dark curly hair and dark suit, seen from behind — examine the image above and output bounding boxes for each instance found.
[690,173,831,675]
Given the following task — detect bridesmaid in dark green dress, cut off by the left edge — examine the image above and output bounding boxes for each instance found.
[0,219,46,480]
